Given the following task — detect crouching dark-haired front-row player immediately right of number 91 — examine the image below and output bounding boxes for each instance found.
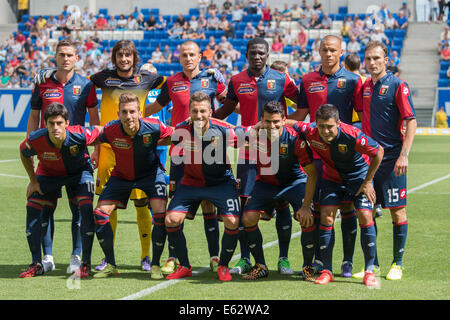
[236,101,317,280]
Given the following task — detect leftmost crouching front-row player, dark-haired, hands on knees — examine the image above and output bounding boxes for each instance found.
[20,103,99,278]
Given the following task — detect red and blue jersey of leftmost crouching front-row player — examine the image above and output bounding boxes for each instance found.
[20,126,99,177]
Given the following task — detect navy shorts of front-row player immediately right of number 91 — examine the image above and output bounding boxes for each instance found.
[244,180,306,213]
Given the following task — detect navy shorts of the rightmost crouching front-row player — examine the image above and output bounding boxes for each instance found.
[320,179,373,211]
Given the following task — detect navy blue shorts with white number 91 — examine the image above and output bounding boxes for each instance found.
[167,180,241,219]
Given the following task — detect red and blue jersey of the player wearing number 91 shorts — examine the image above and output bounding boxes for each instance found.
[172,119,237,187]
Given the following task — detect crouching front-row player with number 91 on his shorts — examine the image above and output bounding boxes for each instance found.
[166,91,240,281]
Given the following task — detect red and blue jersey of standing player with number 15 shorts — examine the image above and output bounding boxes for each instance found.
[356,72,416,156]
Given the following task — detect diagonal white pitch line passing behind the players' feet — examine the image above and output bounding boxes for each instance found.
[118,174,450,300]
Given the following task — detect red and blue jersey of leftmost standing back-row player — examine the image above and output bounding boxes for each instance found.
[30,73,98,128]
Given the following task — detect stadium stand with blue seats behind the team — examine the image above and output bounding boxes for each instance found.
[0,1,410,88]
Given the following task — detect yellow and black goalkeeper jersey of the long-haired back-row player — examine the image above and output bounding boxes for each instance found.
[90,69,165,126]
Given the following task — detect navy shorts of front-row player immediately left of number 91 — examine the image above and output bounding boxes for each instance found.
[98,168,167,209]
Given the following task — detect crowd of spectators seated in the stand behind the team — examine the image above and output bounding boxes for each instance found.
[0,0,412,88]
